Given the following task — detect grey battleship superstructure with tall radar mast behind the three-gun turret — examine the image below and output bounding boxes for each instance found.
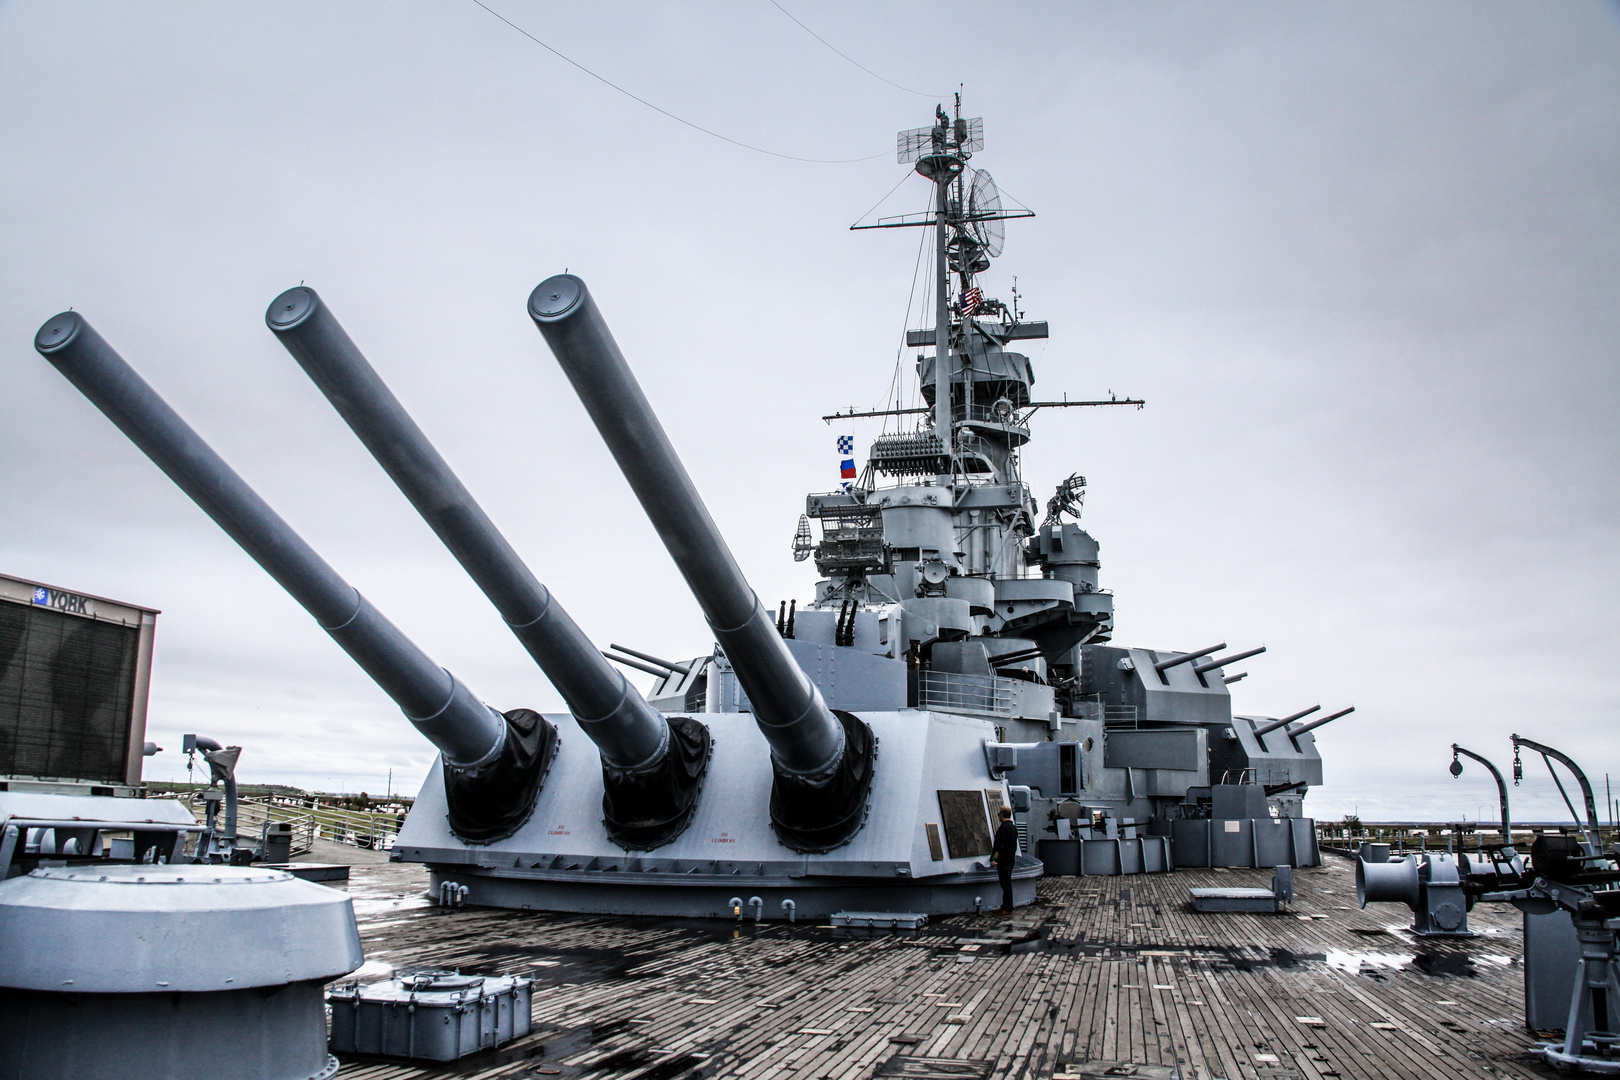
[642,100,1351,873]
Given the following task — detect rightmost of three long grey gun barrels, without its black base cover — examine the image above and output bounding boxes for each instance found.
[528,274,844,776]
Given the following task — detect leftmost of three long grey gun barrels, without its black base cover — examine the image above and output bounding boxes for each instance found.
[34,311,507,769]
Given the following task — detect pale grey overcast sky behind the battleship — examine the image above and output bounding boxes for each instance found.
[0,0,1620,819]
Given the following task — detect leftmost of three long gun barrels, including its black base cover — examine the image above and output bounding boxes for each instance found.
[34,311,557,842]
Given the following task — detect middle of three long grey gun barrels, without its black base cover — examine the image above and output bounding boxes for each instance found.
[264,285,669,771]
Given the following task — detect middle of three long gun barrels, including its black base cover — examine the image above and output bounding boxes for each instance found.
[264,285,710,850]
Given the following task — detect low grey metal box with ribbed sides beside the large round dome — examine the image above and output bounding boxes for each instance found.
[326,972,535,1061]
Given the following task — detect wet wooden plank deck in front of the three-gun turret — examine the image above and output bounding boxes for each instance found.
[339,857,1552,1080]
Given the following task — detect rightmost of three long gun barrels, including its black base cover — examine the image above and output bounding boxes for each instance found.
[528,274,876,852]
